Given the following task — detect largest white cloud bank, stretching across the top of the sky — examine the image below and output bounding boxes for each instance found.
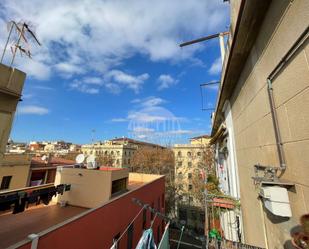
[0,0,228,80]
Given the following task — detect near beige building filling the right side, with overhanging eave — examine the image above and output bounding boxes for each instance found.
[211,0,309,248]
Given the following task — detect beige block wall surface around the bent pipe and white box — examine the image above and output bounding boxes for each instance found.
[230,0,309,248]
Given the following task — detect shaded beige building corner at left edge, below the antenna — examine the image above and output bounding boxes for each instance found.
[0,64,26,157]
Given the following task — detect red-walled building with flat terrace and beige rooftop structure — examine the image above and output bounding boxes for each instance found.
[0,168,165,249]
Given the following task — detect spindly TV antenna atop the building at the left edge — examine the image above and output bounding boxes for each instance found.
[0,21,41,67]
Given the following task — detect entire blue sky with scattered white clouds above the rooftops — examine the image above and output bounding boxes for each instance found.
[0,0,229,143]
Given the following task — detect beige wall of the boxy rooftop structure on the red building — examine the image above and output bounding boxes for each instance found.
[54,168,128,208]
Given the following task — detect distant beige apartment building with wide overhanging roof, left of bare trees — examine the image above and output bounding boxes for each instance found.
[81,137,163,168]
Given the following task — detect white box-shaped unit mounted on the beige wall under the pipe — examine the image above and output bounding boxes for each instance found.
[260,186,292,217]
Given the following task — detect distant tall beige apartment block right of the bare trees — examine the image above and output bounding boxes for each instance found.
[172,135,210,230]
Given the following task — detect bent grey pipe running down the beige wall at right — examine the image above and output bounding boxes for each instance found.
[267,26,309,173]
